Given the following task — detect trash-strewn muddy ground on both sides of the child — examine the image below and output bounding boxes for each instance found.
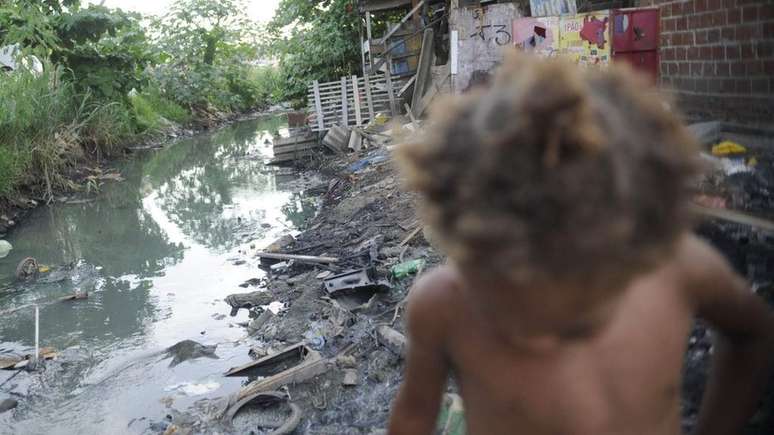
[183,119,774,434]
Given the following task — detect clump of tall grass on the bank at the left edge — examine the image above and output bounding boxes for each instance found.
[0,64,132,199]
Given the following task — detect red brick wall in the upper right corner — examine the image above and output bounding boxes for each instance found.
[640,0,774,125]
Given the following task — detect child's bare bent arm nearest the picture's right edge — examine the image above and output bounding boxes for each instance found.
[690,240,774,435]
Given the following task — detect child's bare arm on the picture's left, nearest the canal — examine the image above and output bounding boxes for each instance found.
[389,273,449,435]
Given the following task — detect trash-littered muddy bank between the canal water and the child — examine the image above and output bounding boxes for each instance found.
[148,116,446,434]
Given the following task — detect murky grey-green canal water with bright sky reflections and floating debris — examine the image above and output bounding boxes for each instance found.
[0,117,315,434]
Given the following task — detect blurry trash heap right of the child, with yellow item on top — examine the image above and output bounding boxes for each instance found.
[683,122,774,435]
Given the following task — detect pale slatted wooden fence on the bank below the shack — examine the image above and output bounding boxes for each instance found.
[307,74,406,131]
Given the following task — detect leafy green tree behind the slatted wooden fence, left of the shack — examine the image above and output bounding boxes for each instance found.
[264,0,361,103]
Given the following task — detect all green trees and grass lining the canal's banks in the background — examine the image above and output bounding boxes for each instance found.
[0,0,360,202]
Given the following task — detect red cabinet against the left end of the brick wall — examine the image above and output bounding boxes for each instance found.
[612,8,660,80]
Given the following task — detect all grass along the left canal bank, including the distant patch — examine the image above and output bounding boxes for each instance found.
[0,62,283,200]
